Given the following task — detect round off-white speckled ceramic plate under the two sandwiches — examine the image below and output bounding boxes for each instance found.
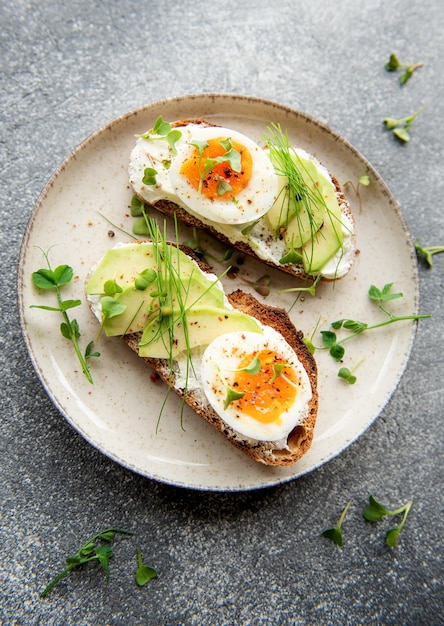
[19,94,418,491]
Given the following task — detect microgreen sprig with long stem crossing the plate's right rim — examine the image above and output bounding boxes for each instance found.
[321,283,431,361]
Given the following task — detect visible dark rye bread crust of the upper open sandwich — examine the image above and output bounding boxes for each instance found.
[130,118,356,281]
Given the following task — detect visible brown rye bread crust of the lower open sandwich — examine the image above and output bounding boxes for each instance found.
[111,242,318,465]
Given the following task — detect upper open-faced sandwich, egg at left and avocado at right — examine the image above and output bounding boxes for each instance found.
[129,116,356,280]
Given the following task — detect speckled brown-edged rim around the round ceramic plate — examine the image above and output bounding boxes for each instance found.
[18,93,419,491]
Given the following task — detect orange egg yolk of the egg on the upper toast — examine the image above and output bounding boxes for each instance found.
[180,137,253,202]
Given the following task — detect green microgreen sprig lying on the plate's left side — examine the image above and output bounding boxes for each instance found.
[30,250,100,384]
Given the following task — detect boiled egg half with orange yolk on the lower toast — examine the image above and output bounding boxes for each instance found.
[201,326,312,441]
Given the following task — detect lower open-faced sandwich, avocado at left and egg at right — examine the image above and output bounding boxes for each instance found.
[86,220,318,465]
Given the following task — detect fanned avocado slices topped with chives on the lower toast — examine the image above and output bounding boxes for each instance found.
[86,241,262,359]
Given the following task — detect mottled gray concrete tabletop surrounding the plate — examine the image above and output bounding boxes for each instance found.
[0,0,444,626]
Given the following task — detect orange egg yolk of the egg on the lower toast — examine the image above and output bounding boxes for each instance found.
[233,350,297,423]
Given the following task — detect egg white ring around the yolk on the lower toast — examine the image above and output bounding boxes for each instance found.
[201,326,312,441]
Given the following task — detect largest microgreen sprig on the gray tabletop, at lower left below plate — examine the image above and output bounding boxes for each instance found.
[40,528,133,598]
